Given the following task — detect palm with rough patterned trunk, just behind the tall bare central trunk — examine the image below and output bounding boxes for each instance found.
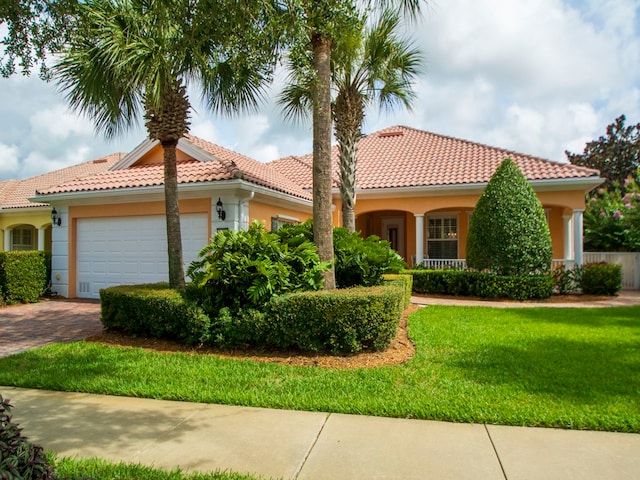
[280,10,422,232]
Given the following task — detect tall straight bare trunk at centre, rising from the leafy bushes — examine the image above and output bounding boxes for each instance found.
[311,35,336,290]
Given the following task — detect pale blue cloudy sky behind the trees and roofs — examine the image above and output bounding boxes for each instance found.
[0,0,640,180]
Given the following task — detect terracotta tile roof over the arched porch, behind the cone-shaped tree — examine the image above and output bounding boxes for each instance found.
[269,126,599,189]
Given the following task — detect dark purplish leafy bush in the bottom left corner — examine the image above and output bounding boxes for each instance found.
[0,394,58,480]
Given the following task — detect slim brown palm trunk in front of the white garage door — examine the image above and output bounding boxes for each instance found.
[162,141,185,292]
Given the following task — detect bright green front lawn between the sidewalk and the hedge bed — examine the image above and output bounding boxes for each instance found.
[0,306,640,432]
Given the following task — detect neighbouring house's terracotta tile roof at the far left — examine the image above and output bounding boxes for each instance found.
[0,153,123,210]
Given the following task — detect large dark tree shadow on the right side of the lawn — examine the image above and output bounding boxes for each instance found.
[451,338,640,402]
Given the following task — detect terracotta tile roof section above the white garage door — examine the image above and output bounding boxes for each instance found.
[38,136,311,200]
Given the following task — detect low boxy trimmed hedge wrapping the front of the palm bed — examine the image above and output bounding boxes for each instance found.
[100,282,404,354]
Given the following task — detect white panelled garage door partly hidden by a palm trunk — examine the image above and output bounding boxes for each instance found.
[76,214,208,298]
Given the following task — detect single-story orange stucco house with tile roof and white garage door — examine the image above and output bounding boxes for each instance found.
[0,126,602,298]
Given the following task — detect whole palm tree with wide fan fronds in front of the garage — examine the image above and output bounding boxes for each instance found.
[54,0,277,290]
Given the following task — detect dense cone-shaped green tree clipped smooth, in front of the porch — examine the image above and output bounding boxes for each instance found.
[467,158,552,275]
